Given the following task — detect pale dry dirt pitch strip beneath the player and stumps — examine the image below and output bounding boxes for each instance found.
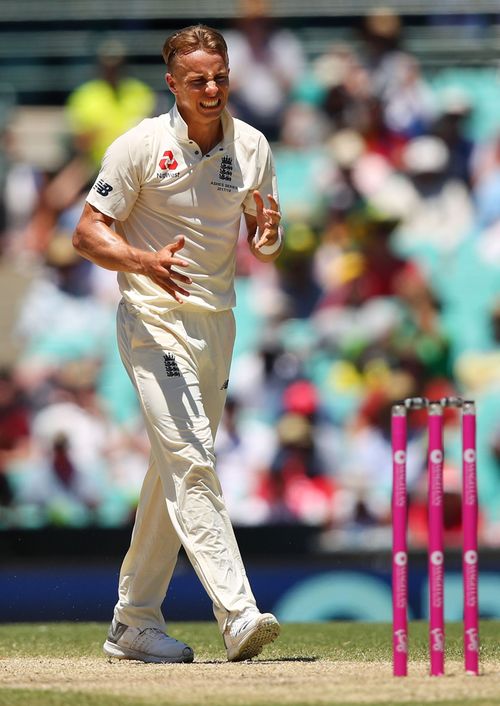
[0,657,500,706]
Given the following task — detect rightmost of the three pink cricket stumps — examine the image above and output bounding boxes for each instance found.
[462,401,479,675]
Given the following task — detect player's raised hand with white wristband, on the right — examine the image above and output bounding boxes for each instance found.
[245,191,283,262]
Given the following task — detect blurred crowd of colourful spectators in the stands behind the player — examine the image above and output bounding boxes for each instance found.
[0,3,500,548]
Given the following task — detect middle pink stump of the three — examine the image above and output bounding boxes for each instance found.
[428,402,445,676]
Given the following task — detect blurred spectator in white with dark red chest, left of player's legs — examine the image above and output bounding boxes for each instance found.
[18,361,119,524]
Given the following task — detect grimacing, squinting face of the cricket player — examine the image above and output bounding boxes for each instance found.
[166,49,229,125]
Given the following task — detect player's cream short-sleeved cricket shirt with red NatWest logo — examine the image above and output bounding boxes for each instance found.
[87,106,278,315]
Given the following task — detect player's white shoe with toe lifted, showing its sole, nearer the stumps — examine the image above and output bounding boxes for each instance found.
[223,609,280,662]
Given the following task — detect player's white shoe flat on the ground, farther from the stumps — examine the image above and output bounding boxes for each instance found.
[103,618,194,663]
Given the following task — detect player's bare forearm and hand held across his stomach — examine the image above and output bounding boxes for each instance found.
[73,203,191,302]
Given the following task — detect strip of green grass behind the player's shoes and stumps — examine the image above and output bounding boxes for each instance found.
[0,621,500,660]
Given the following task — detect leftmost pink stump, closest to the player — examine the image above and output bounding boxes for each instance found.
[391,404,408,677]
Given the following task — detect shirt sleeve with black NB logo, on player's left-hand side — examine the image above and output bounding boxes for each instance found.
[87,129,148,221]
